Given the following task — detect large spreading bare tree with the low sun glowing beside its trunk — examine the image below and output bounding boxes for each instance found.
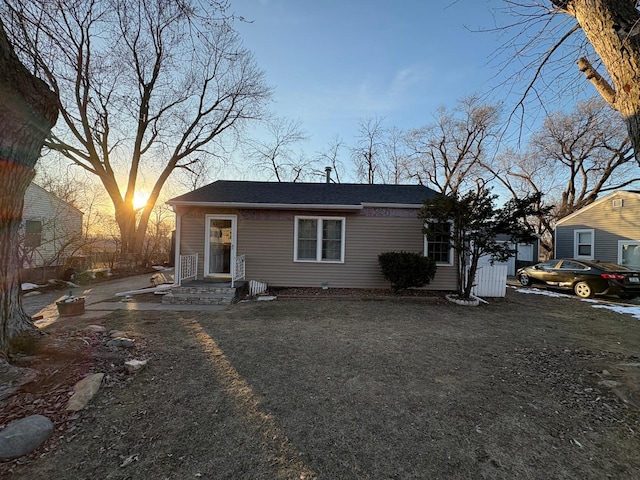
[4,0,270,253]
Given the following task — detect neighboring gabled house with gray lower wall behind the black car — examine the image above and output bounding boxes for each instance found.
[555,190,640,268]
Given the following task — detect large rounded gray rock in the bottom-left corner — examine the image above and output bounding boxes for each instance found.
[0,415,53,460]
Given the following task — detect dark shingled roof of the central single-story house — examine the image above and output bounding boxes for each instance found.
[167,180,436,207]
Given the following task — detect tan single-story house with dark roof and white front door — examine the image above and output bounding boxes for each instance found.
[167,180,456,290]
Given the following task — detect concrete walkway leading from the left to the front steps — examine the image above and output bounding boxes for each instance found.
[22,273,227,326]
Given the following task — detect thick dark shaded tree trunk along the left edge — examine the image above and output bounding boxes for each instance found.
[0,21,58,357]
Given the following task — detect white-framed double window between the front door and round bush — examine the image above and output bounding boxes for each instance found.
[294,217,345,262]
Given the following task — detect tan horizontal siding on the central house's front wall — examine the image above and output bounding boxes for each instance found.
[175,205,455,290]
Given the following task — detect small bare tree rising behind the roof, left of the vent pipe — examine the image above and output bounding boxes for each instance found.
[247,117,311,182]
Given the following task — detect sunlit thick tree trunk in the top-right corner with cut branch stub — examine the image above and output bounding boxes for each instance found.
[551,0,640,164]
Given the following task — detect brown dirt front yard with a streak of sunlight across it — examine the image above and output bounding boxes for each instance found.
[0,290,640,480]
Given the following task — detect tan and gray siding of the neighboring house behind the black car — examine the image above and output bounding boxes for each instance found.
[555,192,640,263]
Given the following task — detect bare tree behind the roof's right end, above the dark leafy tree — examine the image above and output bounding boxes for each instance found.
[406,97,499,195]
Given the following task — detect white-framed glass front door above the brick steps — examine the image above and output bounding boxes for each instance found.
[204,215,236,278]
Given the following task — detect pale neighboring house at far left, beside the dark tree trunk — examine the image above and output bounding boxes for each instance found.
[20,183,83,268]
